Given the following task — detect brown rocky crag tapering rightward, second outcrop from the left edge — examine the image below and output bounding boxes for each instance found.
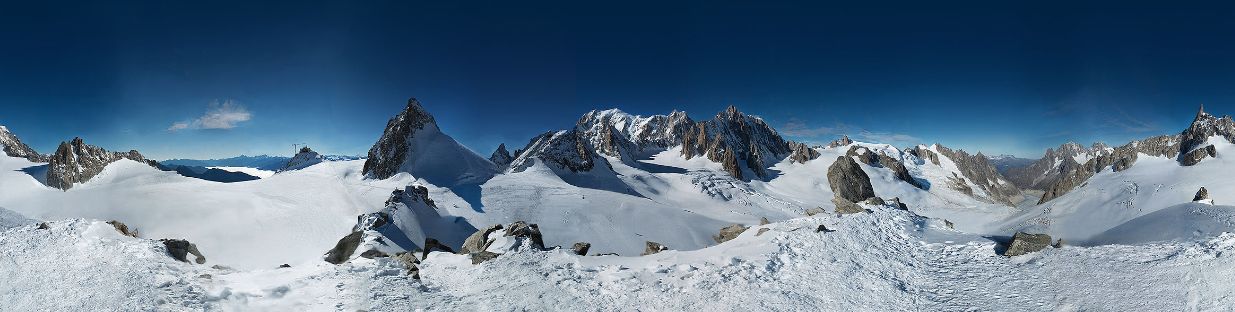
[47,138,158,190]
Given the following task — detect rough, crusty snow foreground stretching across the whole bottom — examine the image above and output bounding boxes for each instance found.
[9,202,1235,311]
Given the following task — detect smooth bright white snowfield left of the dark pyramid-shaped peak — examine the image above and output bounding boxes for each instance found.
[0,157,411,268]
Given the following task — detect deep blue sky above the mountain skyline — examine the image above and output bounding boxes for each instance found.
[0,1,1235,159]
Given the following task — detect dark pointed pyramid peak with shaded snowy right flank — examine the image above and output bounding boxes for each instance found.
[363,99,496,186]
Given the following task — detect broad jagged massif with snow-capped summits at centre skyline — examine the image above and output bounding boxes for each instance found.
[509,106,800,179]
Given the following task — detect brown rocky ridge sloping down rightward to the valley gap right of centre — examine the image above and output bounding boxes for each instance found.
[935,144,1020,206]
